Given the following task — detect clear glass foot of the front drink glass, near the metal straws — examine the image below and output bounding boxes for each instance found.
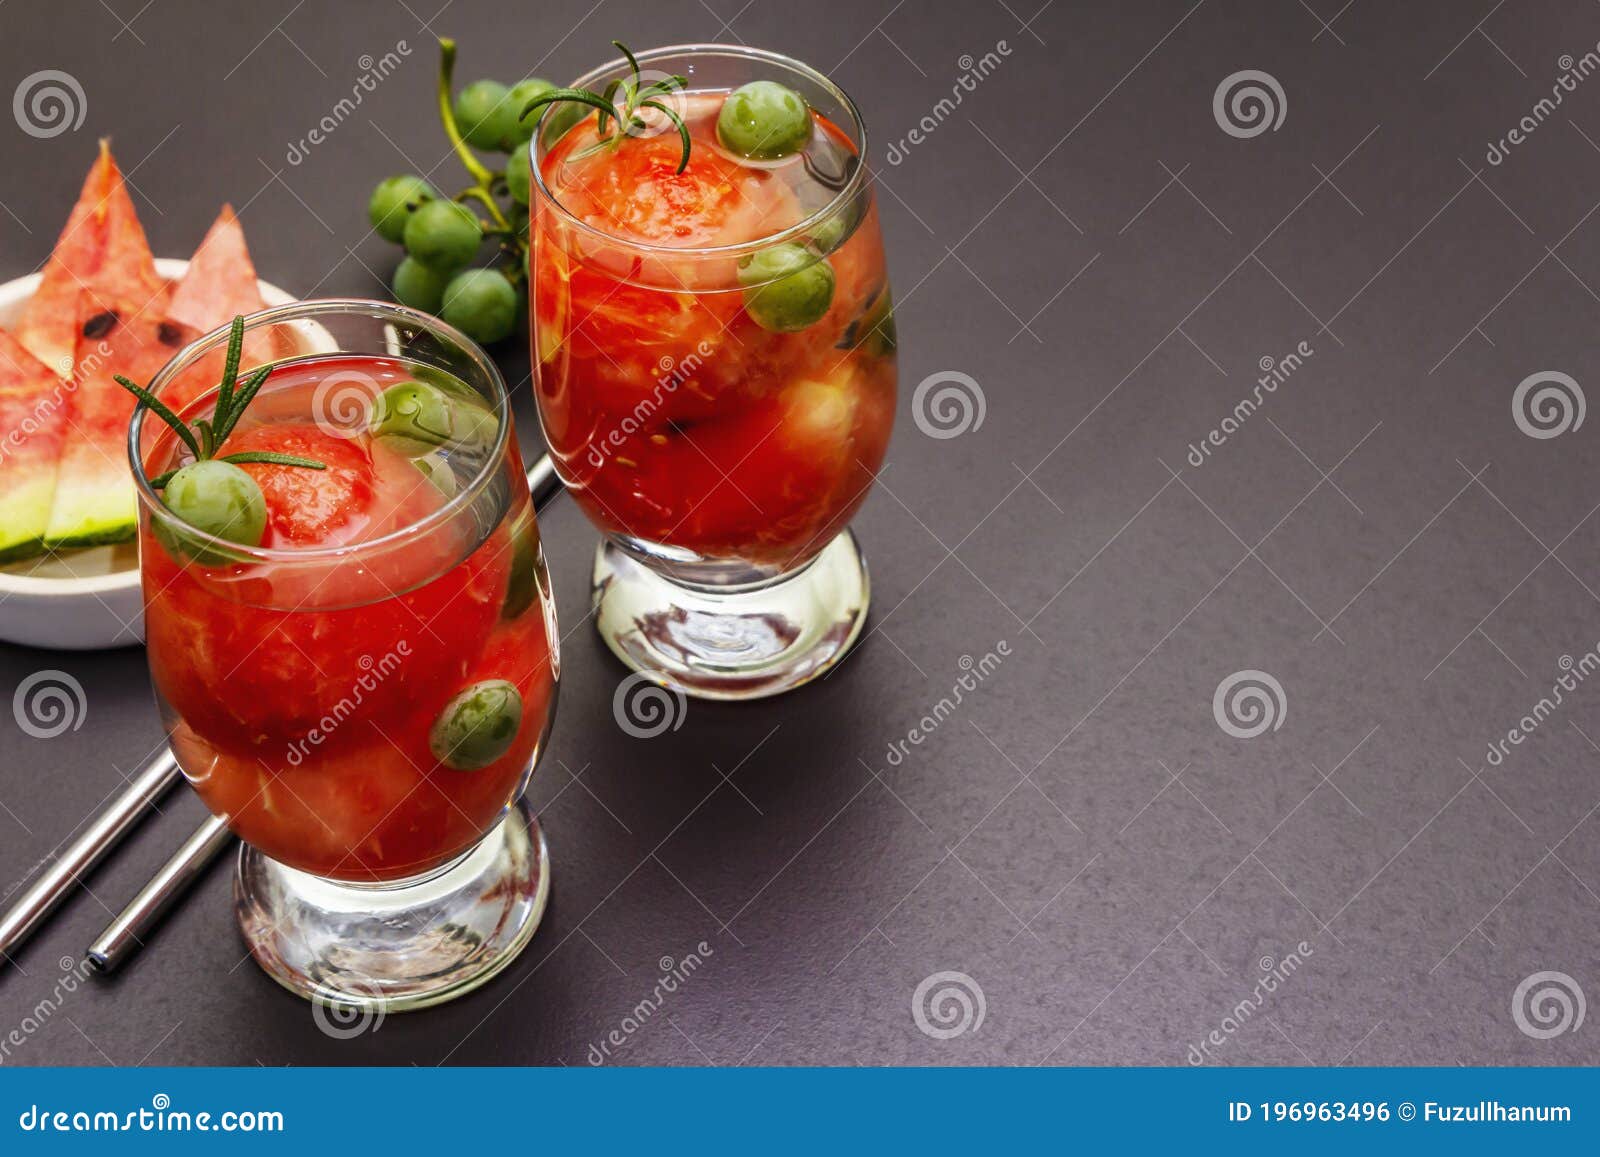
[234,800,550,1013]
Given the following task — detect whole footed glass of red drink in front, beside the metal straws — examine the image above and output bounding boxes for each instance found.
[128,301,560,1010]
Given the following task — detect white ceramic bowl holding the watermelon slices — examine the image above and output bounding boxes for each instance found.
[0,258,294,651]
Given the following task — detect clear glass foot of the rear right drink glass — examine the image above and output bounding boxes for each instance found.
[594,530,870,699]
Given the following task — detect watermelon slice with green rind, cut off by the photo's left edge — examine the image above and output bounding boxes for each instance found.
[0,330,70,562]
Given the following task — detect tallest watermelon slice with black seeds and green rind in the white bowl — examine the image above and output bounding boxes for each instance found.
[45,142,173,549]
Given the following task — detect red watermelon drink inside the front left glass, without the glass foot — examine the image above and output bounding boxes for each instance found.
[141,355,554,882]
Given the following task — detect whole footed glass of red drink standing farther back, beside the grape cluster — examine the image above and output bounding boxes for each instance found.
[530,45,896,699]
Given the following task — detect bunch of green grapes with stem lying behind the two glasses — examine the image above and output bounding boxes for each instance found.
[366,40,566,344]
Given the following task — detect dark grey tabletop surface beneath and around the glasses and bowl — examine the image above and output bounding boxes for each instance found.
[0,0,1600,1064]
